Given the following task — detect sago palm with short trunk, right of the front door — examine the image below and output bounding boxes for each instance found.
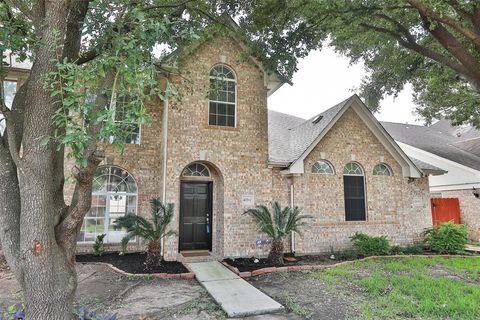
[244,201,308,265]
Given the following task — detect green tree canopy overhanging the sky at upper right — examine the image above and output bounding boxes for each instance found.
[235,0,480,127]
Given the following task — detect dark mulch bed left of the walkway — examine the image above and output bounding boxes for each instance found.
[76,252,190,274]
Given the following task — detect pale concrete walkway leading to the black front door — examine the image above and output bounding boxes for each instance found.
[188,261,283,317]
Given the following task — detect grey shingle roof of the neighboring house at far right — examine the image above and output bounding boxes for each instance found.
[382,120,480,170]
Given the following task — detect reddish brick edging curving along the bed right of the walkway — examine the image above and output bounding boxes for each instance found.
[222,254,480,278]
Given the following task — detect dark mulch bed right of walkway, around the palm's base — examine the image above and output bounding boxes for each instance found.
[223,255,345,272]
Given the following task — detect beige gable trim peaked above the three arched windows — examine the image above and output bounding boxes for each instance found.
[285,94,424,178]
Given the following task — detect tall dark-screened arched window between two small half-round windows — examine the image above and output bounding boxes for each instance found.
[343,162,367,221]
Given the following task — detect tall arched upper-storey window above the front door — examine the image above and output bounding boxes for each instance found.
[208,64,237,127]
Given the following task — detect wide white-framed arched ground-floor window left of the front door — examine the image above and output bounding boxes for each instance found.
[77,166,138,243]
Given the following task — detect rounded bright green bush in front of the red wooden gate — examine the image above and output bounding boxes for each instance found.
[425,221,468,253]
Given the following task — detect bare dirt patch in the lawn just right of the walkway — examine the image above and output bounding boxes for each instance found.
[248,272,359,320]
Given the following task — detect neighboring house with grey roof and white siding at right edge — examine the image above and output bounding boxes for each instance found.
[382,120,480,241]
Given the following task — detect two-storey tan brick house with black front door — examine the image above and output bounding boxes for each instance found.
[0,36,439,260]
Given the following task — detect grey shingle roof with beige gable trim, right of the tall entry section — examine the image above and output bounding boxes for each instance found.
[269,95,422,177]
